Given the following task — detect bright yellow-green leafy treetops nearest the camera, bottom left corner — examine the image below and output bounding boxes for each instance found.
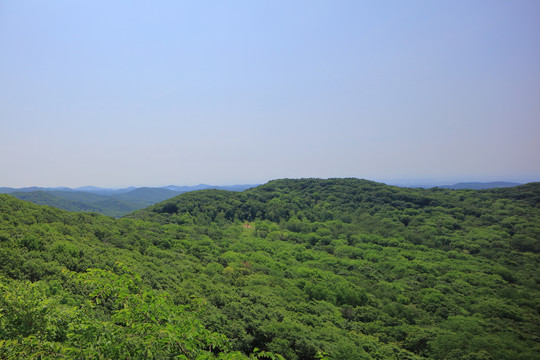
[0,264,280,359]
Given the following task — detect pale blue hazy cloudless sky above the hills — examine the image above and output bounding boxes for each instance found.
[0,0,540,187]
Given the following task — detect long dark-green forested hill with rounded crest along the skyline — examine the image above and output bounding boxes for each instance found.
[128,178,540,257]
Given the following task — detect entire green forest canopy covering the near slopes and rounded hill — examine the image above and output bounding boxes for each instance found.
[0,178,540,360]
